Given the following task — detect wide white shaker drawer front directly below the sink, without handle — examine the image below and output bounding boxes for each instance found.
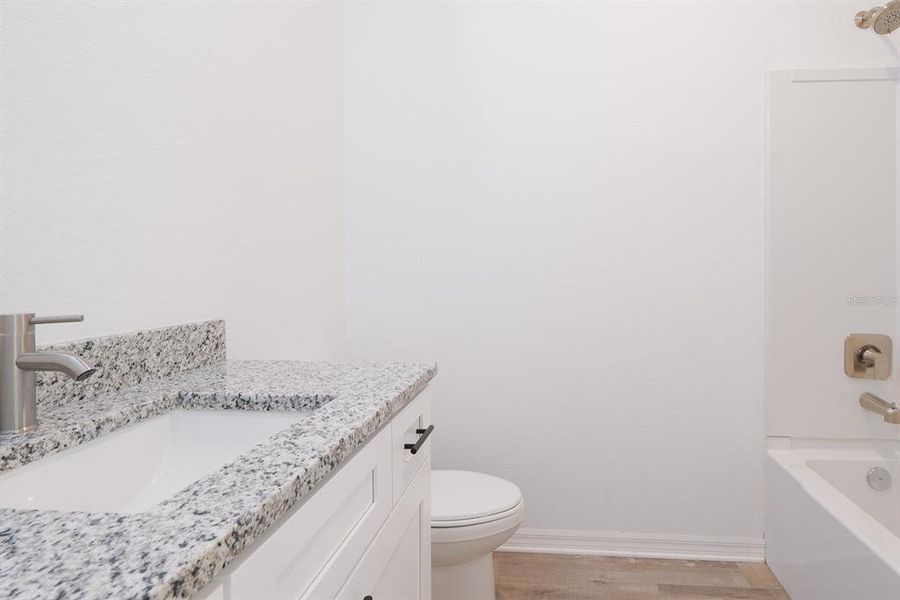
[227,428,393,600]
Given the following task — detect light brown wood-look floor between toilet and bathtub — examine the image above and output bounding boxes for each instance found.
[494,552,790,600]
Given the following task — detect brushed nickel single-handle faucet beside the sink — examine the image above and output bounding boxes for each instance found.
[0,313,96,434]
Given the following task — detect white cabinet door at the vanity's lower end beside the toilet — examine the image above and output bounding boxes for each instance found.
[338,459,431,600]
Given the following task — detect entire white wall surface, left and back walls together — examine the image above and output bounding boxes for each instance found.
[7,1,898,552]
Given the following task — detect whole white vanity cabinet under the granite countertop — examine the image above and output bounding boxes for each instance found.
[197,390,431,600]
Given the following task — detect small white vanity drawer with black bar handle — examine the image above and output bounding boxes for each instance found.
[391,389,432,504]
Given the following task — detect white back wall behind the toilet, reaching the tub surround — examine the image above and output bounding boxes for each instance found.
[344,2,897,546]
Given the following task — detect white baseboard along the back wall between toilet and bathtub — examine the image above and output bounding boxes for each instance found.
[499,529,765,562]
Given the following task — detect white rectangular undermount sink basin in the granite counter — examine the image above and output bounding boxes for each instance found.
[0,410,303,513]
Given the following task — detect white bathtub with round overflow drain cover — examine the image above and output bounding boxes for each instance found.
[766,438,900,600]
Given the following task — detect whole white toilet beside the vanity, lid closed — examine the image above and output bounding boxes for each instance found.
[431,470,525,600]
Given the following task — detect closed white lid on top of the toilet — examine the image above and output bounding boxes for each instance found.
[431,470,522,522]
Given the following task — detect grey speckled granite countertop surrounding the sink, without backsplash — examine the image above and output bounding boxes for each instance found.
[0,361,436,598]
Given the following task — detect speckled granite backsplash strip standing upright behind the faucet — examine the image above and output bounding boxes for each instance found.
[35,321,225,406]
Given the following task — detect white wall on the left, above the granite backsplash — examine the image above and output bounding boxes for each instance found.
[0,0,344,358]
